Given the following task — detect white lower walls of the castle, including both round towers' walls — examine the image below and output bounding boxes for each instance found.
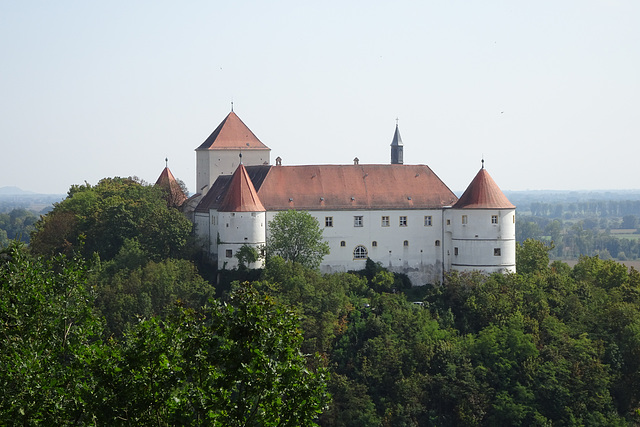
[196,203,515,286]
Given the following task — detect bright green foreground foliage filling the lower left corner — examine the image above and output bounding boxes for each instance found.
[0,245,328,426]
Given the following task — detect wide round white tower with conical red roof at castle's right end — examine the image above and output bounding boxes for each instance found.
[448,160,516,273]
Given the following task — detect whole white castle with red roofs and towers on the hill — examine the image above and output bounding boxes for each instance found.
[180,111,516,285]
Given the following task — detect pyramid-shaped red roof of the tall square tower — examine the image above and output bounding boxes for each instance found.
[196,111,269,150]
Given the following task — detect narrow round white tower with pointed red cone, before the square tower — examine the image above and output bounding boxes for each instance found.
[218,163,267,269]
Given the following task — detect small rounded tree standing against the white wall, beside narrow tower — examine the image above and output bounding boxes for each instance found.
[267,210,329,268]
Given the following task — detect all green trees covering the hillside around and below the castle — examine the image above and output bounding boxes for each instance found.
[0,183,640,426]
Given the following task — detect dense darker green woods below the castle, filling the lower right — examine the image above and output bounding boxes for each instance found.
[245,240,640,426]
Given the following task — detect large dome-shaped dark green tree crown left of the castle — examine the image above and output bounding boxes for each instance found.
[31,178,191,261]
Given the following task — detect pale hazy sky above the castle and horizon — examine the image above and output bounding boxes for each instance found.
[0,0,640,193]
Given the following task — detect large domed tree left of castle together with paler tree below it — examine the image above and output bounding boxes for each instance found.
[26,178,208,336]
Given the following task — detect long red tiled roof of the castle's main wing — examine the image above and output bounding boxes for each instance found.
[198,165,457,211]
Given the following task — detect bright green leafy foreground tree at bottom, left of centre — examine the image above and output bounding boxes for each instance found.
[91,284,329,426]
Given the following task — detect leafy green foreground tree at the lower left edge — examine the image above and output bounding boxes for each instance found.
[0,241,102,425]
